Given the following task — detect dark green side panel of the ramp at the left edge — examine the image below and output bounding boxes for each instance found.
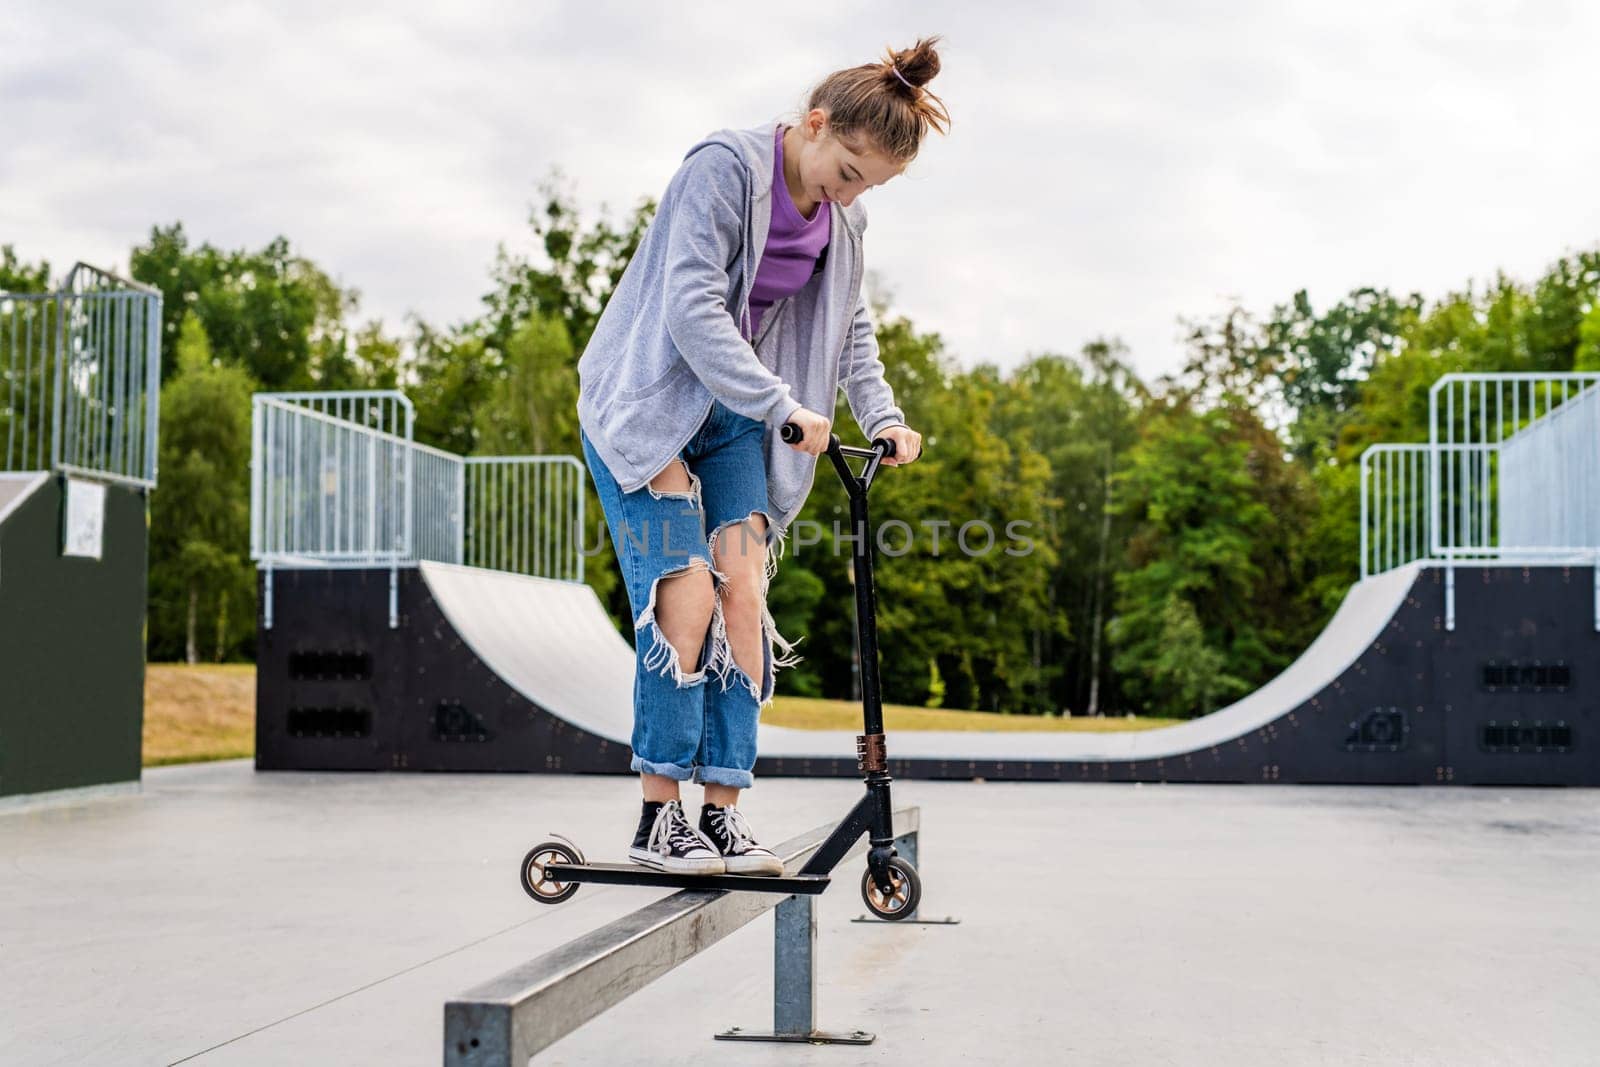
[0,475,149,795]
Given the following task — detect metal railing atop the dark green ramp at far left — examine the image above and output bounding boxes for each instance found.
[0,262,162,488]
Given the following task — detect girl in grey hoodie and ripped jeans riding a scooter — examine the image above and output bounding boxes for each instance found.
[578,37,949,875]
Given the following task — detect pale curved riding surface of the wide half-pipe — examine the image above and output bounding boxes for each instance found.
[421,561,1421,761]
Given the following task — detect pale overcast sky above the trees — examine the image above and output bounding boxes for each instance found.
[0,0,1600,383]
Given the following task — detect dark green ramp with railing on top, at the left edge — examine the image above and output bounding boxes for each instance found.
[0,262,162,809]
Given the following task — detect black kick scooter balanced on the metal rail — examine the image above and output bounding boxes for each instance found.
[520,422,922,920]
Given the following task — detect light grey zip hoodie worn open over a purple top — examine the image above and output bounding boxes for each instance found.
[578,123,906,533]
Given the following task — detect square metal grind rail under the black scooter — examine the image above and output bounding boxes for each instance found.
[445,806,922,1067]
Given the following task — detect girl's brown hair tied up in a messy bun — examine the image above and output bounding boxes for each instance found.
[806,35,950,163]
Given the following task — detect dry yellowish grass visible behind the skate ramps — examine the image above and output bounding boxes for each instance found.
[144,664,1179,766]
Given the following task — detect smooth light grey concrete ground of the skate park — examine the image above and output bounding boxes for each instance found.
[0,761,1600,1067]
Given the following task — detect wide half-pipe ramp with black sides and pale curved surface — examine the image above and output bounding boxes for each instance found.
[256,561,1600,785]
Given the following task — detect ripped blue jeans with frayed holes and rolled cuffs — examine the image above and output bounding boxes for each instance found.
[579,402,797,789]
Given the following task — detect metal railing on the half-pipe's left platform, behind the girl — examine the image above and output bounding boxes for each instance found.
[250,390,584,629]
